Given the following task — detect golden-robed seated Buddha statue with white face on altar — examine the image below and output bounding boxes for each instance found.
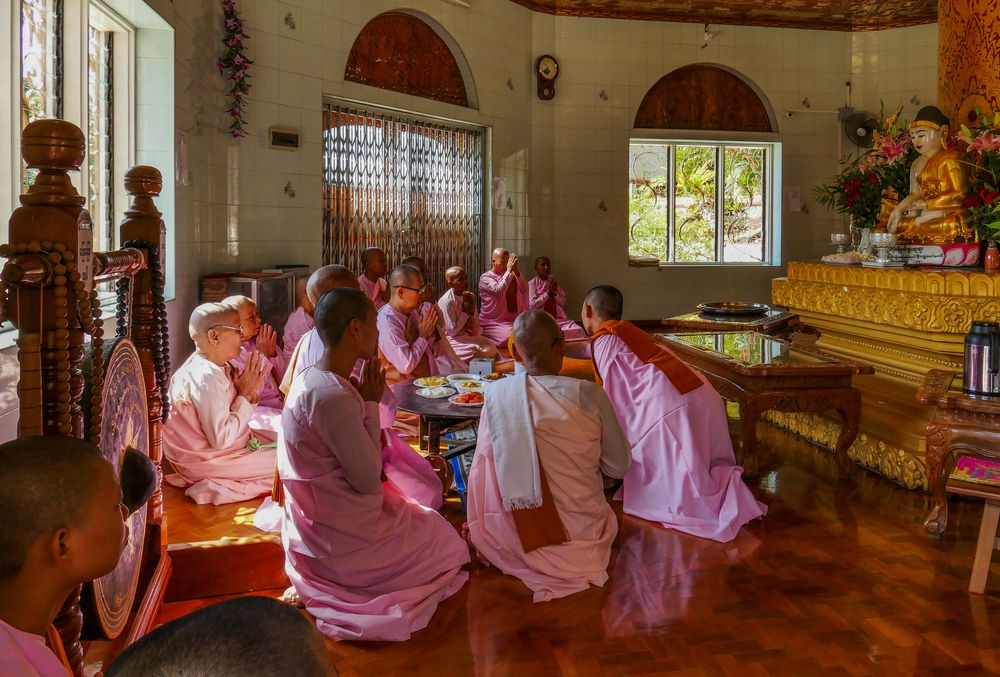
[888,106,977,244]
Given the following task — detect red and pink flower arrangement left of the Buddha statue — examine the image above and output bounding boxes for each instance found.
[813,110,917,227]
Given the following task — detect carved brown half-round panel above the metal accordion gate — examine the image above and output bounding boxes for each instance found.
[344,12,469,107]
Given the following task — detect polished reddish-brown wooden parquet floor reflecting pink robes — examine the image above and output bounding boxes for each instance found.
[160,426,1000,676]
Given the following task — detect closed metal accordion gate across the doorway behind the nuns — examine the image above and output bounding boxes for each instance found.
[323,102,485,294]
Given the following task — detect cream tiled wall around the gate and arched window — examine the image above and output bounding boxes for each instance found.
[0,0,936,437]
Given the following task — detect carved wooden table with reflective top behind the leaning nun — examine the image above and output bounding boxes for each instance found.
[653,332,875,472]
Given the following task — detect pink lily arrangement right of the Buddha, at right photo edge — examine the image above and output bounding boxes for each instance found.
[958,109,1000,240]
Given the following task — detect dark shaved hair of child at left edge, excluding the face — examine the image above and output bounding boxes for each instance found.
[0,435,108,581]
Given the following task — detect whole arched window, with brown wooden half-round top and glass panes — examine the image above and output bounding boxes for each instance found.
[629,64,780,264]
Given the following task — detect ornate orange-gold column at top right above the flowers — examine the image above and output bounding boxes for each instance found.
[938,0,1000,131]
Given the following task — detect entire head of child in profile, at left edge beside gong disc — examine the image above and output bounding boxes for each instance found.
[0,435,127,586]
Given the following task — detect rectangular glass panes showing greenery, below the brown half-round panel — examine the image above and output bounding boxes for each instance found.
[629,140,776,264]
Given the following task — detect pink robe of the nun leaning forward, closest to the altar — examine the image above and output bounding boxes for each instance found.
[592,335,767,543]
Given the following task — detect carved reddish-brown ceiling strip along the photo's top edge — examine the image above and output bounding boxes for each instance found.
[513,0,936,31]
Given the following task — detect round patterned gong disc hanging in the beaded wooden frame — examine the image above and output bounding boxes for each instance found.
[80,338,149,639]
